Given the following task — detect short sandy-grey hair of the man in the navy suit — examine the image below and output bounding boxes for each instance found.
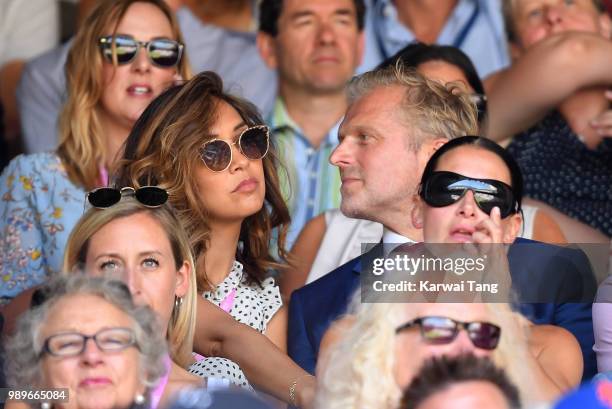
[348,60,478,150]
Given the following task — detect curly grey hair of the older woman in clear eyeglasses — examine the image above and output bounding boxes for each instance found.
[5,274,168,388]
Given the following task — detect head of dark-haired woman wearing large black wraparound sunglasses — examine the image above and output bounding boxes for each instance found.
[414,136,523,244]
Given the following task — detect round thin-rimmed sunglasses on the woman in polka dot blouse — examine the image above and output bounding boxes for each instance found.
[200,125,270,172]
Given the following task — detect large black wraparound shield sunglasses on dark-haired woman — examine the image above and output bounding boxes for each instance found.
[419,171,518,219]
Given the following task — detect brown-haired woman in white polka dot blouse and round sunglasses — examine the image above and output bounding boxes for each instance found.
[116,72,312,401]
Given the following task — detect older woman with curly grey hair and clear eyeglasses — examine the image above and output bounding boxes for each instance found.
[7,275,166,409]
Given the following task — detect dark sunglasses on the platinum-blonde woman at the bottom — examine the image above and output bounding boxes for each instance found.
[395,317,501,350]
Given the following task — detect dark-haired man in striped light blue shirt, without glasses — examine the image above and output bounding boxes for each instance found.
[257,0,365,247]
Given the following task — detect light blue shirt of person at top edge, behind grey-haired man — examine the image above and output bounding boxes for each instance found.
[357,0,510,78]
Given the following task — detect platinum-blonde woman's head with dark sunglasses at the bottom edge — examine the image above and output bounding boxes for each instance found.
[316,300,550,409]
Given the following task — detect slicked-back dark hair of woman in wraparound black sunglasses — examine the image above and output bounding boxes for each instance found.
[421,136,524,213]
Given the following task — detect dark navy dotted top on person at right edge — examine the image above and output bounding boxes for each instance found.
[508,111,612,236]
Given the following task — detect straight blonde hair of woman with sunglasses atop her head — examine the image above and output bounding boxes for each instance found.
[62,197,197,367]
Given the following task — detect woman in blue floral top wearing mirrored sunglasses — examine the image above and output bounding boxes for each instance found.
[0,0,191,303]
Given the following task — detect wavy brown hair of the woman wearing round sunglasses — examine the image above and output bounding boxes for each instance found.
[114,71,290,291]
